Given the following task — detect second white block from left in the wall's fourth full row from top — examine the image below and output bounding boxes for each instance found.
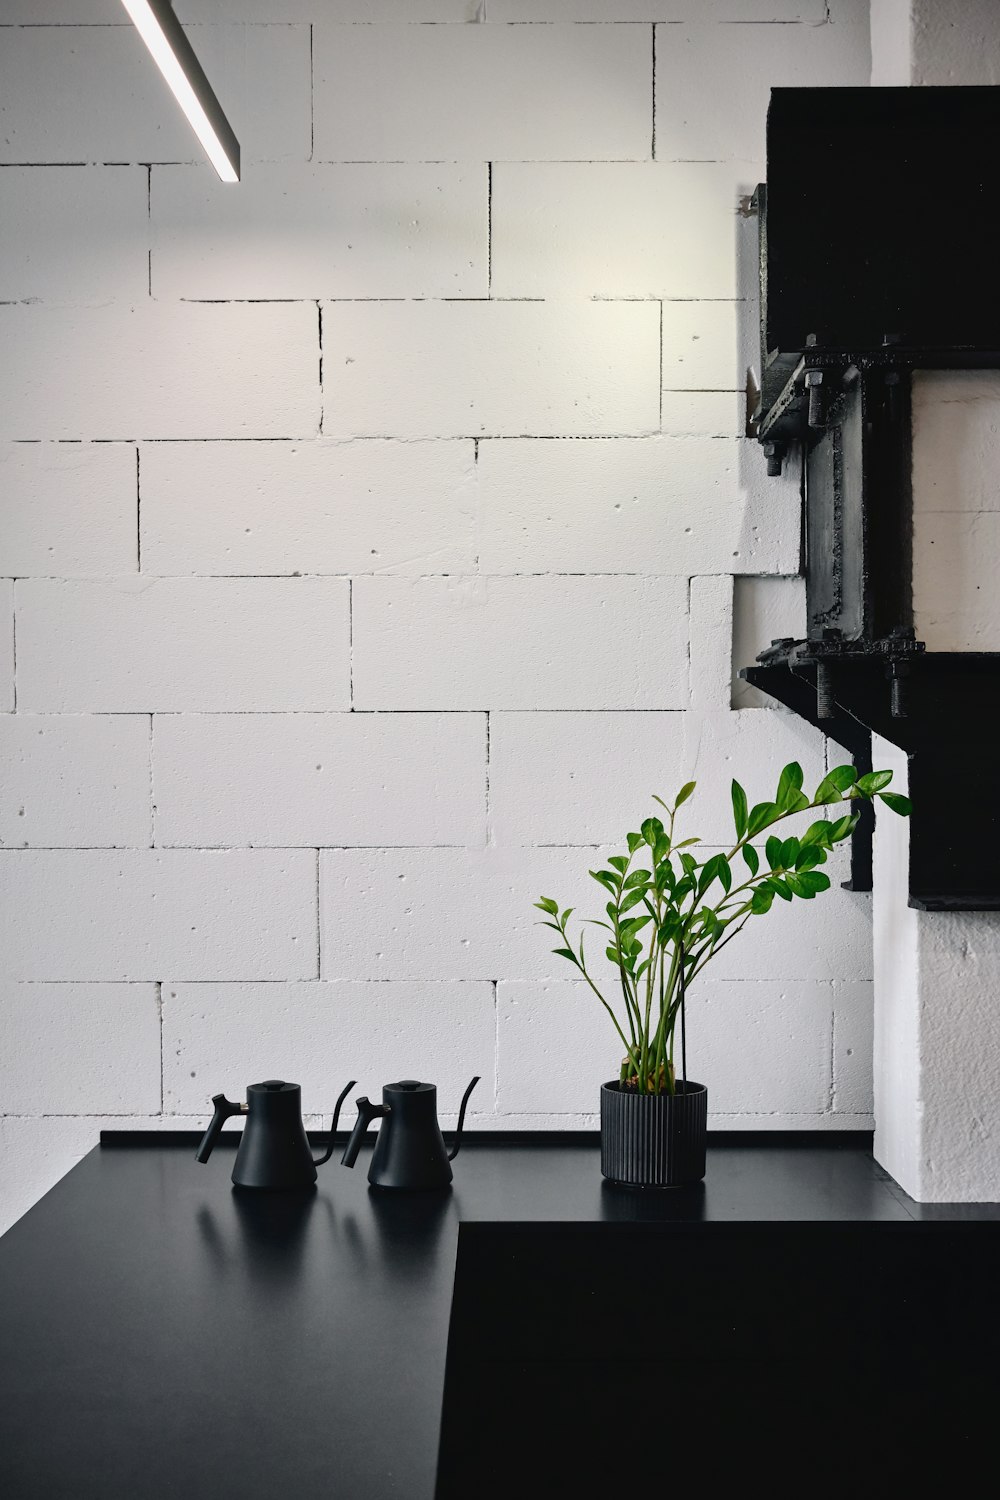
[138,440,477,578]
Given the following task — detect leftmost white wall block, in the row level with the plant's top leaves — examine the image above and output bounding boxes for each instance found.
[0,713,151,849]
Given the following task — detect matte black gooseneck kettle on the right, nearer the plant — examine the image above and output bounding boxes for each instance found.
[340,1077,480,1191]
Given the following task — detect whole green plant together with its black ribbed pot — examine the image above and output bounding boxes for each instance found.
[535,761,910,1188]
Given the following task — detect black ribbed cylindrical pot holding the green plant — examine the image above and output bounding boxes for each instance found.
[601,1082,708,1188]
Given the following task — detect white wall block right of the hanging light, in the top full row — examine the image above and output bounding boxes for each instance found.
[315,26,652,162]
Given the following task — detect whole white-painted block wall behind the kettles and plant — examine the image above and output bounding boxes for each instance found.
[0,0,875,1227]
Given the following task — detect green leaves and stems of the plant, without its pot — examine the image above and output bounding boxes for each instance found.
[535,761,910,1094]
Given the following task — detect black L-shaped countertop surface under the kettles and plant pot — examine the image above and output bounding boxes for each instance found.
[0,1133,1000,1500]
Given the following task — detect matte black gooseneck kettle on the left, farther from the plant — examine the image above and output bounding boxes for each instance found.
[195,1079,357,1191]
